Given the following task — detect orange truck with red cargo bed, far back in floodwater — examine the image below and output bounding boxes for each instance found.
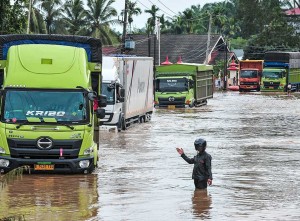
[239,60,264,92]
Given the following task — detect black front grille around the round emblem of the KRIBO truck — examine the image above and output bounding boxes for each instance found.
[7,139,82,159]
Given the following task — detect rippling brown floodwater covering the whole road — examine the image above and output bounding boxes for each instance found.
[0,92,300,221]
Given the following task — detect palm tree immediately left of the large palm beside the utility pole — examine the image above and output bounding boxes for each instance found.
[63,0,87,35]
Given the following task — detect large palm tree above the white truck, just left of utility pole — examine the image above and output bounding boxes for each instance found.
[87,0,120,45]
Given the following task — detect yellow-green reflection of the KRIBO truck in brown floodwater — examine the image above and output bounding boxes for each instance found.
[0,175,98,220]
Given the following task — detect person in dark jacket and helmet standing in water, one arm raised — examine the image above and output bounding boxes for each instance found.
[176,138,212,189]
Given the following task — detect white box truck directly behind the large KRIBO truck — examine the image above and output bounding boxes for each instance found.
[100,56,154,131]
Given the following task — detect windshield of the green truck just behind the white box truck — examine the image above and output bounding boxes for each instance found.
[157,78,188,92]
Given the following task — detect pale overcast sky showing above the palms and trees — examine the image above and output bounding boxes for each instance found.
[112,0,221,32]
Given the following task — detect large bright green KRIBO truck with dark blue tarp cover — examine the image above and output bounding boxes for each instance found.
[0,35,106,173]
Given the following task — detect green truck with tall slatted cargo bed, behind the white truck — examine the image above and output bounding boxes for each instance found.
[154,63,213,108]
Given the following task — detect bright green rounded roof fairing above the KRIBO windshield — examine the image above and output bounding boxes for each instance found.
[3,44,90,88]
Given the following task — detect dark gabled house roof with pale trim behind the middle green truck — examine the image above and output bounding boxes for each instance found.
[103,34,237,65]
